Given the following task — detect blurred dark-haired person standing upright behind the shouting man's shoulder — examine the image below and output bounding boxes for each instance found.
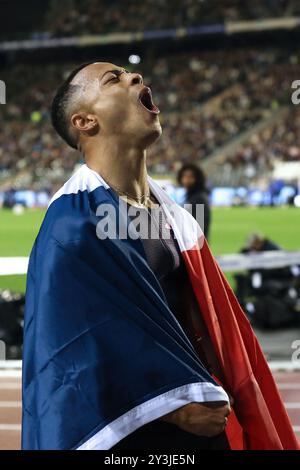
[177,163,211,239]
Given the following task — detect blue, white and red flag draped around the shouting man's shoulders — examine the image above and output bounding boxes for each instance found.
[22,165,297,449]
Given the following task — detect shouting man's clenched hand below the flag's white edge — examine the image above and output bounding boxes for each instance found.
[160,402,231,437]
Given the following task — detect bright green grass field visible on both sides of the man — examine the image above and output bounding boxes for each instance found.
[0,207,300,292]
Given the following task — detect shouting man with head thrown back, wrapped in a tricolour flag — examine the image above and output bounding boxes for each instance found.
[22,62,298,450]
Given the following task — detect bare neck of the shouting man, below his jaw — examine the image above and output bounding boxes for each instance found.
[85,139,149,199]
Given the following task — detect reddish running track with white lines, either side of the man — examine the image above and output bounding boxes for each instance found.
[0,372,300,450]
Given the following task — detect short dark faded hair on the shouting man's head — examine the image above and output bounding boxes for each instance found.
[51,62,94,150]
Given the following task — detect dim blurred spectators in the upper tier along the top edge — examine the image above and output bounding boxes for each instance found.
[45,0,300,36]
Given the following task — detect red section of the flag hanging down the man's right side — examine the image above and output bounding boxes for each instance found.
[182,241,300,450]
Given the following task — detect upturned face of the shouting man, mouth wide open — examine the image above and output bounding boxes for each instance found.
[72,62,162,147]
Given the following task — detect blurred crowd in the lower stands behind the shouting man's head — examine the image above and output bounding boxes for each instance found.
[0,49,300,189]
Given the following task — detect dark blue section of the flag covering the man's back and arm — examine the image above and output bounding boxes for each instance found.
[22,186,223,449]
